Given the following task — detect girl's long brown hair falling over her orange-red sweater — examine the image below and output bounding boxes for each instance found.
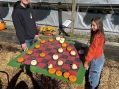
[90,17,105,43]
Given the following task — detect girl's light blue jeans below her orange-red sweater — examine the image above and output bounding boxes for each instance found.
[89,55,105,89]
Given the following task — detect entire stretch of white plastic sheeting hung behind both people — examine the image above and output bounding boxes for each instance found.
[3,7,119,33]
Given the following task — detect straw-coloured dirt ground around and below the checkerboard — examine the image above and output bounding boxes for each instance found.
[0,29,119,89]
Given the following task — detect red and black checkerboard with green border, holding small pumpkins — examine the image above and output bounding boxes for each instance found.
[8,37,85,84]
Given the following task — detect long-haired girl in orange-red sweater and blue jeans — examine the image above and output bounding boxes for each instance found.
[84,17,105,89]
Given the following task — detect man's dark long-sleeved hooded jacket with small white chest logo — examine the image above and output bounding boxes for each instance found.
[12,1,38,44]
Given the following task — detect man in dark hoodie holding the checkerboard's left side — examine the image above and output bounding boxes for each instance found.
[12,0,39,50]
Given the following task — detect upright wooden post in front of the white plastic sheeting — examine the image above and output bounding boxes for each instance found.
[71,0,76,36]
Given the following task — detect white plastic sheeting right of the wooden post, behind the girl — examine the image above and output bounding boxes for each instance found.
[76,13,119,32]
